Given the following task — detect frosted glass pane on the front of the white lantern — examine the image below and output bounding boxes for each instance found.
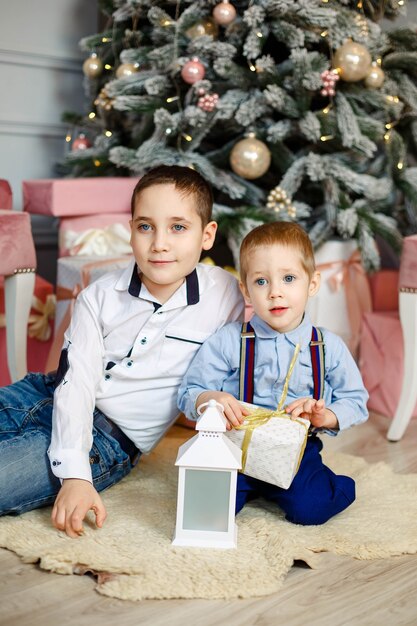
[183,469,230,532]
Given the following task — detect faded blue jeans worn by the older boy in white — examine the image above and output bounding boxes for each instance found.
[0,374,140,515]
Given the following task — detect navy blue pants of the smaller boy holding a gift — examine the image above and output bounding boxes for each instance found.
[236,435,355,525]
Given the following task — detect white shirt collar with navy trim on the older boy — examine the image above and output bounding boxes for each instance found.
[116,261,200,306]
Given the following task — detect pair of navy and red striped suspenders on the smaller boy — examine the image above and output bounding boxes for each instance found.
[239,322,324,403]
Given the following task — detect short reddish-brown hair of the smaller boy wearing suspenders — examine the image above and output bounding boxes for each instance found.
[240,222,316,284]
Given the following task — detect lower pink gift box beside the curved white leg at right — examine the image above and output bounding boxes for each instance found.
[359,311,417,417]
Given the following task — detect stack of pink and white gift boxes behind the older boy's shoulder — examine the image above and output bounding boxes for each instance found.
[23,177,137,370]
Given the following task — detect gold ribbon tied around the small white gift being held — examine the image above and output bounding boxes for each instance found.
[235,343,308,472]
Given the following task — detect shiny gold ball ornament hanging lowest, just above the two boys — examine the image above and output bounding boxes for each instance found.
[230,136,271,180]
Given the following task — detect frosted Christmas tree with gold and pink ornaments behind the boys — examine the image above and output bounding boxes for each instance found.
[64,0,417,270]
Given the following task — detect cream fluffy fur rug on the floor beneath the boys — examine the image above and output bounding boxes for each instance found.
[0,427,417,600]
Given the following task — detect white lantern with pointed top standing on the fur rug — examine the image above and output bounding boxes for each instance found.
[172,400,242,548]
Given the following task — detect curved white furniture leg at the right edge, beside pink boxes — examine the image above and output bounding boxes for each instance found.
[387,292,417,441]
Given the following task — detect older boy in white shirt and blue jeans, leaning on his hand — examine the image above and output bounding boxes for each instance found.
[0,166,244,537]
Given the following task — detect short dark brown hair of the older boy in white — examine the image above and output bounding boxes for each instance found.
[130,165,213,228]
